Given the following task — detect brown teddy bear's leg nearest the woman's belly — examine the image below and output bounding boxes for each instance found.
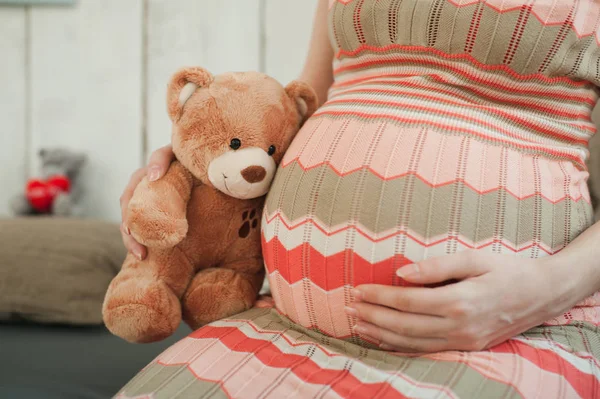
[182,260,264,330]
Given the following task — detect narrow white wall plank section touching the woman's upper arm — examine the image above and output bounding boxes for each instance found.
[264,0,318,85]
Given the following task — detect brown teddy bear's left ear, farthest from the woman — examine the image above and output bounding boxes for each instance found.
[167,67,213,121]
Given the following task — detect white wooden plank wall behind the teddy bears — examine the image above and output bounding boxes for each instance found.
[0,0,316,221]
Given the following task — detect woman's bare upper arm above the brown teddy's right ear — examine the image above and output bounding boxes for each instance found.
[300,0,333,105]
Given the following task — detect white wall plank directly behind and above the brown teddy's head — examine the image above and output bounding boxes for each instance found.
[147,0,260,156]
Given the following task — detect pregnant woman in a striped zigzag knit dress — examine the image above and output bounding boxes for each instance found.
[116,0,600,398]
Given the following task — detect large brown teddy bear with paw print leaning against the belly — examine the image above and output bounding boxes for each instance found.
[103,68,318,342]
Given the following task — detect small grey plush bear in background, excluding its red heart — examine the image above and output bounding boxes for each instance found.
[11,148,87,216]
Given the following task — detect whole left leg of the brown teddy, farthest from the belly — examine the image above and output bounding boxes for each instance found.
[103,247,192,343]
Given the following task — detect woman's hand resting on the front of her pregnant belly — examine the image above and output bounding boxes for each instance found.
[346,251,575,352]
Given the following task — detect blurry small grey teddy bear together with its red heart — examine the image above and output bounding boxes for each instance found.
[11,148,87,216]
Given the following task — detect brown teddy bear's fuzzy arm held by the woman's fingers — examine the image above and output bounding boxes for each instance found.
[126,161,194,248]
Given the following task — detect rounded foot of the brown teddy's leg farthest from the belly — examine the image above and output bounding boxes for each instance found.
[103,280,181,343]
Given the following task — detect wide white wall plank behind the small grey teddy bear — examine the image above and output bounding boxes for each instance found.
[30,0,143,220]
